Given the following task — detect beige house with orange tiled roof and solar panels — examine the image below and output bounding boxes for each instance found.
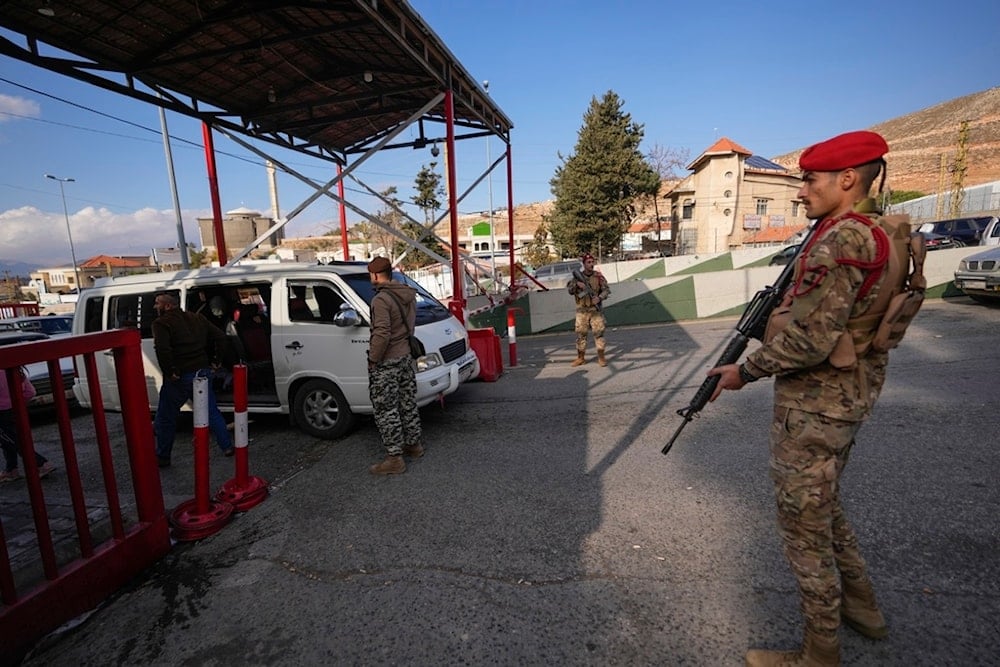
[664,137,809,255]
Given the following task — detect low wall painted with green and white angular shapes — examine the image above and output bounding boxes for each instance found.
[468,247,985,335]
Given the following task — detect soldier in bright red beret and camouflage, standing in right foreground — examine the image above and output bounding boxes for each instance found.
[708,132,889,665]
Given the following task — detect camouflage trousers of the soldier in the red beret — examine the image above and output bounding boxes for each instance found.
[770,407,867,638]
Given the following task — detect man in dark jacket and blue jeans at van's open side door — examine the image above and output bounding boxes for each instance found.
[153,293,234,468]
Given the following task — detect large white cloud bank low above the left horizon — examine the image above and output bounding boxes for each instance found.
[0,206,209,267]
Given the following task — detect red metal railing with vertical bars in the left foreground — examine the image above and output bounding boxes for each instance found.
[0,329,170,660]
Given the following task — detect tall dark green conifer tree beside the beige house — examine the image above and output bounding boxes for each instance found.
[547,90,653,255]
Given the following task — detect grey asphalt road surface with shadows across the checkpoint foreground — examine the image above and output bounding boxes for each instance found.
[9,299,1000,667]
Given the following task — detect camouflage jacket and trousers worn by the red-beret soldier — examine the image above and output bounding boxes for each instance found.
[745,214,888,641]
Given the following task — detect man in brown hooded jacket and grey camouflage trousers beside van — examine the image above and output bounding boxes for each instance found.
[368,257,424,475]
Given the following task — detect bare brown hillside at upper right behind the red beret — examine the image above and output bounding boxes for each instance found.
[771,87,1000,194]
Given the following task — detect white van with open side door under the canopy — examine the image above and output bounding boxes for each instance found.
[73,262,479,438]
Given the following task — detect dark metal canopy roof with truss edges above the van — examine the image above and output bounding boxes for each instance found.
[0,0,512,162]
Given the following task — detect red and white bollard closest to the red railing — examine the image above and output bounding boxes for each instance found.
[170,377,233,542]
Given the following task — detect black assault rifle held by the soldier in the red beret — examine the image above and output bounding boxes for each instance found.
[661,224,819,454]
